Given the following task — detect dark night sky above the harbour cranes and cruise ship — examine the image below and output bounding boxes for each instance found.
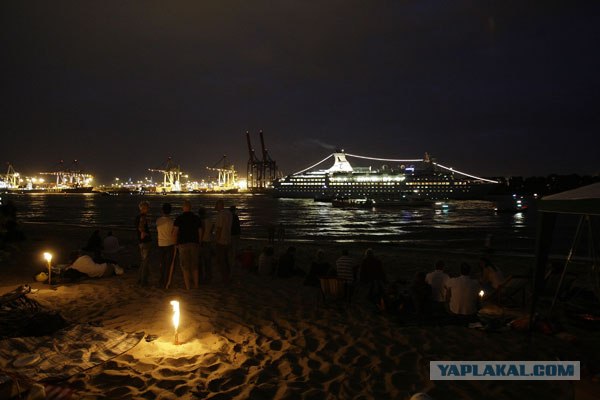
[0,0,600,182]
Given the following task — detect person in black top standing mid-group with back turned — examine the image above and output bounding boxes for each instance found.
[173,200,202,290]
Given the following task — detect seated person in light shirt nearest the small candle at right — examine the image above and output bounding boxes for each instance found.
[446,263,481,316]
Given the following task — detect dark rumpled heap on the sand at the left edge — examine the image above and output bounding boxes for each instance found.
[0,285,67,338]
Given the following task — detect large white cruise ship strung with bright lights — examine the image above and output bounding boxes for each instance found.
[273,151,498,203]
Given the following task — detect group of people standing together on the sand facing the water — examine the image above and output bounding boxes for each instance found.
[135,199,241,289]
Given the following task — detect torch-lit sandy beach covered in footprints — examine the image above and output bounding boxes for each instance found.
[0,224,600,399]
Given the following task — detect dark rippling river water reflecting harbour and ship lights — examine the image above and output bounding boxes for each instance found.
[3,194,536,247]
